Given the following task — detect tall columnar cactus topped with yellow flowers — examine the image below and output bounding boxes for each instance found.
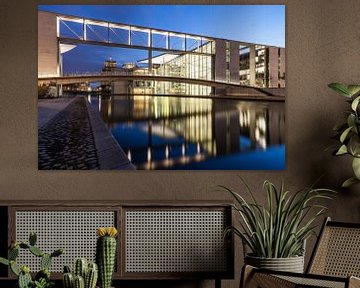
[96,227,117,288]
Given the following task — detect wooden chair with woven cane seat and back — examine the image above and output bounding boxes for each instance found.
[240,218,360,288]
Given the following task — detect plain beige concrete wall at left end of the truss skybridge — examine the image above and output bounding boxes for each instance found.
[34,12,59,75]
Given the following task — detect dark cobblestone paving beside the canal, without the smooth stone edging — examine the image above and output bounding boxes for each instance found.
[38,98,99,170]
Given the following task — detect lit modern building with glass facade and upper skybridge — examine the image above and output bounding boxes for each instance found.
[38,11,285,95]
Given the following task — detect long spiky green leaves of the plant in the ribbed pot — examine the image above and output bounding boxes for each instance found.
[220,179,334,258]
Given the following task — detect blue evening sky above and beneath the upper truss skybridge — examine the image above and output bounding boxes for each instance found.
[38,5,285,72]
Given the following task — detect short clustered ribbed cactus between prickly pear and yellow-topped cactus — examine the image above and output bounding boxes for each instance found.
[63,258,98,288]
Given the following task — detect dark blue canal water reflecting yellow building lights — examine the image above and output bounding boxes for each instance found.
[88,95,285,170]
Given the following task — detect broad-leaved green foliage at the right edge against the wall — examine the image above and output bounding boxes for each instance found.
[328,83,360,187]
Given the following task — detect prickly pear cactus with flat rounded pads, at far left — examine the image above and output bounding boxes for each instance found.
[0,233,64,288]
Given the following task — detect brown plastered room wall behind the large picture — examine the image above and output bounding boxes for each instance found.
[0,0,360,288]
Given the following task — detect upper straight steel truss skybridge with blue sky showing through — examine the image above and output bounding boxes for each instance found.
[56,14,260,55]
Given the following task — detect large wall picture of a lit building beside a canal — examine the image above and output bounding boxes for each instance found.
[38,5,286,170]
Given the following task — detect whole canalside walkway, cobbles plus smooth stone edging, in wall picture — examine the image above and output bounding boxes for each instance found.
[38,97,134,170]
